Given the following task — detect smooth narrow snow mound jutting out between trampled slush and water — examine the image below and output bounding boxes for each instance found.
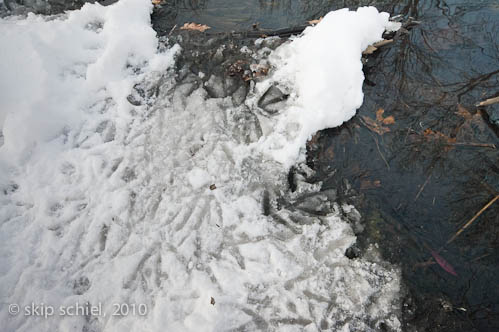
[252,7,400,167]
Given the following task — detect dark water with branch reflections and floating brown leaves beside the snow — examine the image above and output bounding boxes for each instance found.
[0,0,499,331]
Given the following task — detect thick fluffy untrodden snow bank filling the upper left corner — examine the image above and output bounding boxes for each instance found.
[0,0,179,162]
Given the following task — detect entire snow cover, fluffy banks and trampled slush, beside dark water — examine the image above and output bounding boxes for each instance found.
[0,0,400,331]
